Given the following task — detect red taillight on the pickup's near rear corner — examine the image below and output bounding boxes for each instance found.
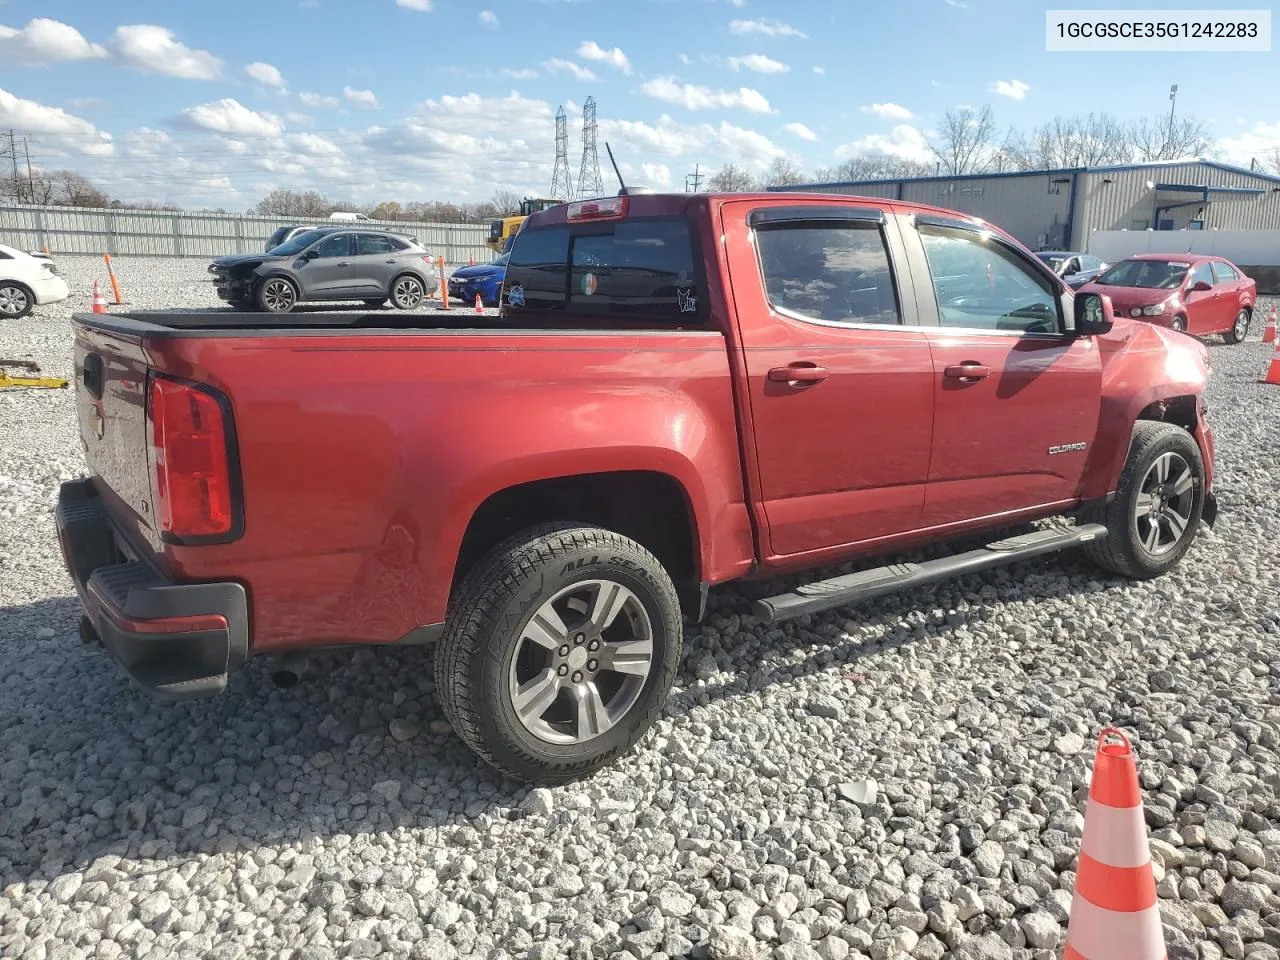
[147,378,236,540]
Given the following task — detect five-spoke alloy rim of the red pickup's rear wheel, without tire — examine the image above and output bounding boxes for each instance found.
[507,580,654,744]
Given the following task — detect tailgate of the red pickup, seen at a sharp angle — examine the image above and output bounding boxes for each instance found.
[76,323,151,529]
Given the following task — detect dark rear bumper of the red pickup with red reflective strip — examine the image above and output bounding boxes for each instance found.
[56,480,248,700]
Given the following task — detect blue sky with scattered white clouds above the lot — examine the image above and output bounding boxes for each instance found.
[0,0,1280,210]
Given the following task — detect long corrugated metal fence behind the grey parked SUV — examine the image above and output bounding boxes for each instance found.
[0,206,493,264]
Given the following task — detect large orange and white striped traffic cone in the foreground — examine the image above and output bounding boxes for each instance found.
[1062,727,1165,960]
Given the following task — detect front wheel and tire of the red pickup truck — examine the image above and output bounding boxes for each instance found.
[1080,420,1204,580]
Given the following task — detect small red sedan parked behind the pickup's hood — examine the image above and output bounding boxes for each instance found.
[1080,253,1258,343]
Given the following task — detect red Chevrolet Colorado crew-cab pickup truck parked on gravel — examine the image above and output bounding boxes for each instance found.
[58,192,1216,781]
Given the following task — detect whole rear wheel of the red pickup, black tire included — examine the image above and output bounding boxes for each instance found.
[435,524,684,783]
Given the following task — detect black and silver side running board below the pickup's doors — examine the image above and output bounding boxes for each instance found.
[753,524,1107,623]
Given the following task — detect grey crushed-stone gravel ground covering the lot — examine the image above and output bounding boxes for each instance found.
[0,259,1280,960]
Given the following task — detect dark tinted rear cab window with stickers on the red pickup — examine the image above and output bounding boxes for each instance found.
[502,218,705,326]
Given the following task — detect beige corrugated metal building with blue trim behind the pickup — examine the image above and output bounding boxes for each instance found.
[773,160,1280,250]
